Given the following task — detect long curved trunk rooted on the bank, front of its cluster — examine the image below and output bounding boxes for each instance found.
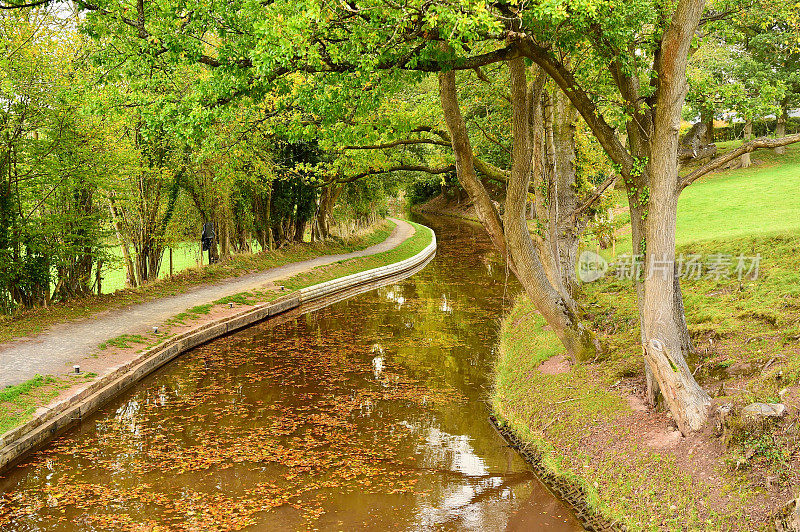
[505,58,600,360]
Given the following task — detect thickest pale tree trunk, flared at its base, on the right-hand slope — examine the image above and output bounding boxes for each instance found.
[644,0,711,434]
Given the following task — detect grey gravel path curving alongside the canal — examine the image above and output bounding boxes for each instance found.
[0,218,414,388]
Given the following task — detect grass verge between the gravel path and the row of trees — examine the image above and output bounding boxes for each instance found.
[0,221,394,342]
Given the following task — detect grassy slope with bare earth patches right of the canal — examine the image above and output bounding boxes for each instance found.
[491,146,800,530]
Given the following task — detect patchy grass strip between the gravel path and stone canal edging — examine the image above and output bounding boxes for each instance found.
[0,222,433,434]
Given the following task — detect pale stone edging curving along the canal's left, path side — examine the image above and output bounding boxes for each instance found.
[0,226,436,472]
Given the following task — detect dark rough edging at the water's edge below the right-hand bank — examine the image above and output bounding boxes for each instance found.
[489,415,625,532]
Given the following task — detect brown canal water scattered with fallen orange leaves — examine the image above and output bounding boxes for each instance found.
[0,217,581,531]
